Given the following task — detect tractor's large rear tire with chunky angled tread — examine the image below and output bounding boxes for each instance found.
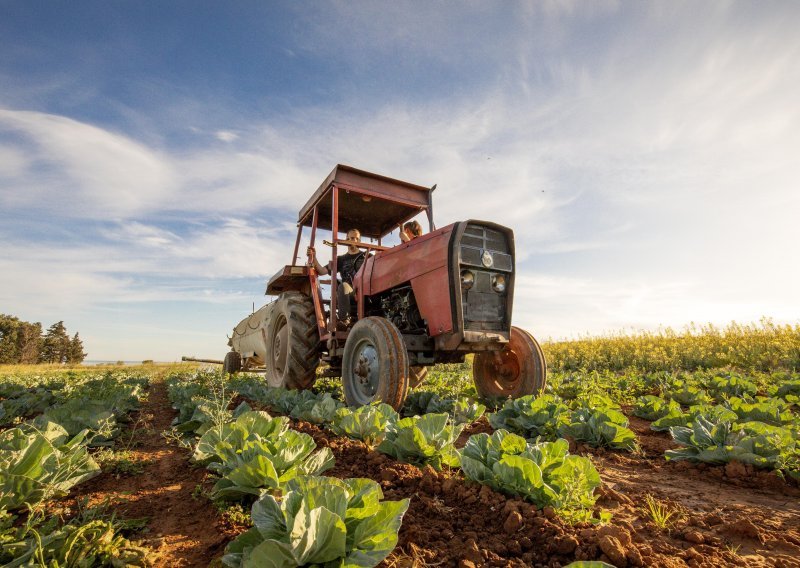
[265,291,319,390]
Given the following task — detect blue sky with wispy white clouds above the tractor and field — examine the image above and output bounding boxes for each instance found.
[0,0,800,361]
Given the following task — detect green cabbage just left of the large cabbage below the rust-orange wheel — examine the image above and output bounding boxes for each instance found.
[378,414,464,469]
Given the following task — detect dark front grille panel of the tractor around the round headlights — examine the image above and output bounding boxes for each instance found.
[459,224,514,331]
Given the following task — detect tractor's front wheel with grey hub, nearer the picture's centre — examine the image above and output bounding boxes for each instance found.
[342,317,409,411]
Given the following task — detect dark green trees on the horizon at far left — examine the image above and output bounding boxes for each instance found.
[0,314,86,364]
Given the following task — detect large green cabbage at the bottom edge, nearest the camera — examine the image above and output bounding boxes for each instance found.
[222,477,409,568]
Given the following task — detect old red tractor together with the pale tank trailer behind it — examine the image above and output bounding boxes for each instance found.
[225,165,547,409]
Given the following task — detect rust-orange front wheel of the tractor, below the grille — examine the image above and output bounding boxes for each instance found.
[472,327,547,398]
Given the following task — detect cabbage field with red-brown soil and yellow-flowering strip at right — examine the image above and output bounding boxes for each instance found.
[0,326,800,567]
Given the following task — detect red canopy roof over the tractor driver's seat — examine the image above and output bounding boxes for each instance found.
[297,164,433,238]
